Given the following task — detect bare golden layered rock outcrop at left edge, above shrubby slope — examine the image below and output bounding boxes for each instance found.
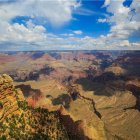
[0,74,22,122]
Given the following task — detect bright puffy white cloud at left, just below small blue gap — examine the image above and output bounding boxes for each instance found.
[0,23,46,42]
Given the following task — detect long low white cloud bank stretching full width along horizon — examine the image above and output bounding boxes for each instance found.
[0,18,140,50]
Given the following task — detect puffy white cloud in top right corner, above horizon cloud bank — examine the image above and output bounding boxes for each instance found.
[103,0,140,39]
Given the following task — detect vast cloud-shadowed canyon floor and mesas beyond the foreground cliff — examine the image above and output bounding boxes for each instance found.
[0,51,140,140]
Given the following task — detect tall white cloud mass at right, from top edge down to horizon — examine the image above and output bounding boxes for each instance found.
[87,0,140,49]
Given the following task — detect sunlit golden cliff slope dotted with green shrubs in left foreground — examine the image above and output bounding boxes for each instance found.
[0,74,69,140]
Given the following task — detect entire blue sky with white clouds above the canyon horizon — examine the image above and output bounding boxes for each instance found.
[0,0,140,51]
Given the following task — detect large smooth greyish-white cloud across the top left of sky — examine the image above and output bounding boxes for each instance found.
[0,0,79,26]
